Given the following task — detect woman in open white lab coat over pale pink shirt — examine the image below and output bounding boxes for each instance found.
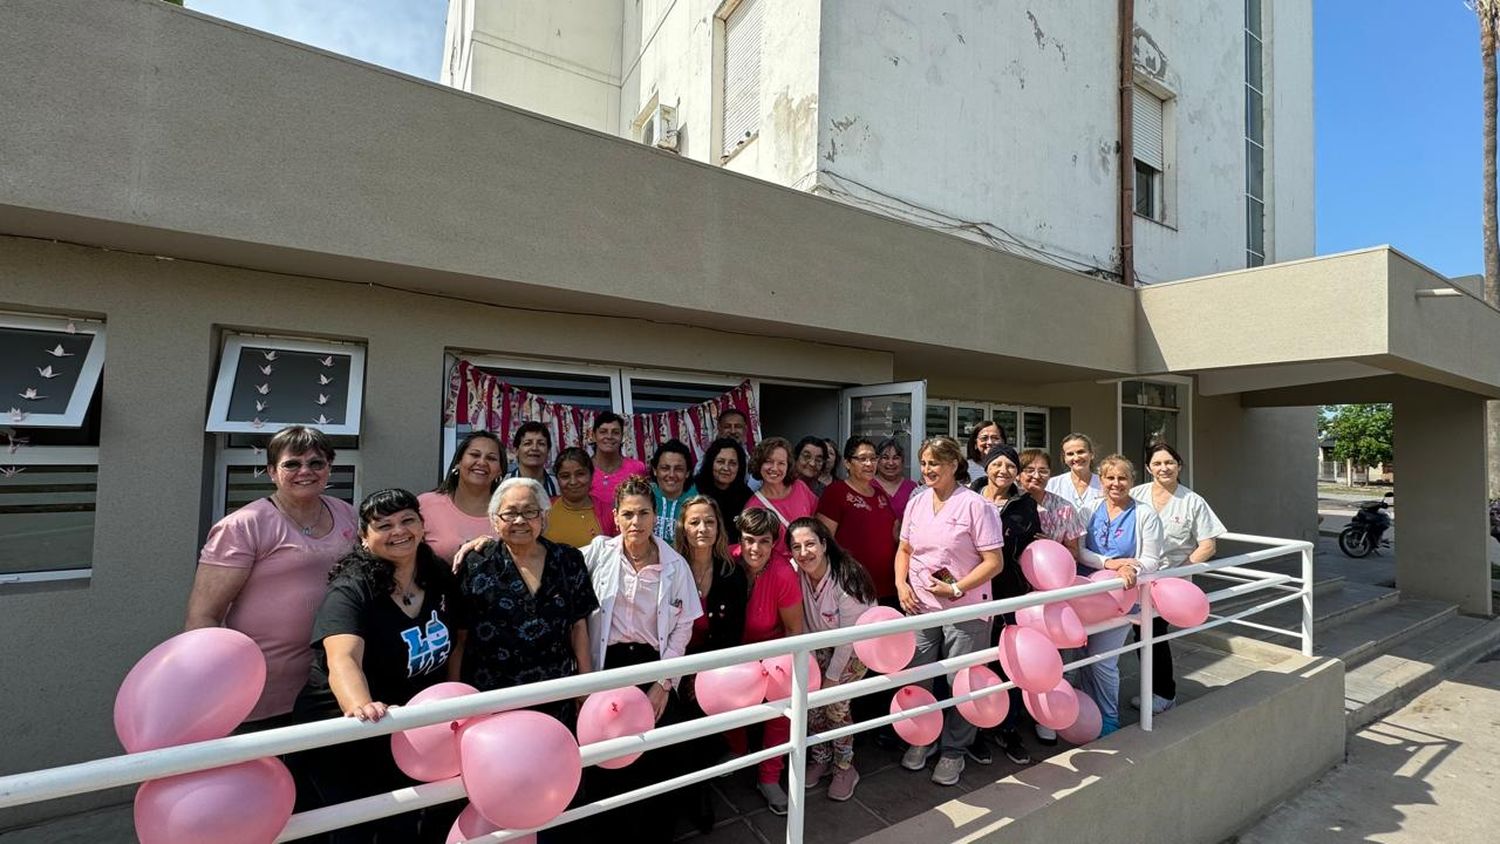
[584,475,704,841]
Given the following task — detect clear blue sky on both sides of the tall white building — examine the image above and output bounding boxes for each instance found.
[188,0,1484,276]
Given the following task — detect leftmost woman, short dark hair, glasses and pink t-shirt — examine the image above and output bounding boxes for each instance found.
[185,426,357,729]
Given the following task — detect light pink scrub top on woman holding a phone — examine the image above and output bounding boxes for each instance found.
[902,486,1004,612]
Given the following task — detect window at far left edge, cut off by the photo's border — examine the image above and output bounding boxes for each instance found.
[0,313,105,583]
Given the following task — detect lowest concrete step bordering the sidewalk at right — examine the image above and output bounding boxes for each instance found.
[1344,616,1500,732]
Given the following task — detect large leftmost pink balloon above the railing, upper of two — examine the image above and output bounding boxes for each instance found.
[114,627,266,753]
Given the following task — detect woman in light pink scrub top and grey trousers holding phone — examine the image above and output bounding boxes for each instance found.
[896,436,1004,786]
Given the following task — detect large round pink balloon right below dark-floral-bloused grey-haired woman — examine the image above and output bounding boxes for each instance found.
[459,709,584,829]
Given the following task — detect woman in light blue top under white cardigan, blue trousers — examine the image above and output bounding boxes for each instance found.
[1079,454,1163,736]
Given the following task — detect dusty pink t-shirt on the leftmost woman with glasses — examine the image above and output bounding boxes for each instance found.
[198,496,359,721]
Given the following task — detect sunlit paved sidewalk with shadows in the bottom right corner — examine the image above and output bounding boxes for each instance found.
[1232,652,1500,844]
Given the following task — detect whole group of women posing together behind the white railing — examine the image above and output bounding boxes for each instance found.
[188,414,1223,841]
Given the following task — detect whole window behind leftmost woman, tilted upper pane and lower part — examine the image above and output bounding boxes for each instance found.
[204,334,365,520]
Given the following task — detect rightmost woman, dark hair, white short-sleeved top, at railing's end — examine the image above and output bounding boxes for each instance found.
[1130,442,1227,712]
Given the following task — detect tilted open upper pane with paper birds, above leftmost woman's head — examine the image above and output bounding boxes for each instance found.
[207,334,365,436]
